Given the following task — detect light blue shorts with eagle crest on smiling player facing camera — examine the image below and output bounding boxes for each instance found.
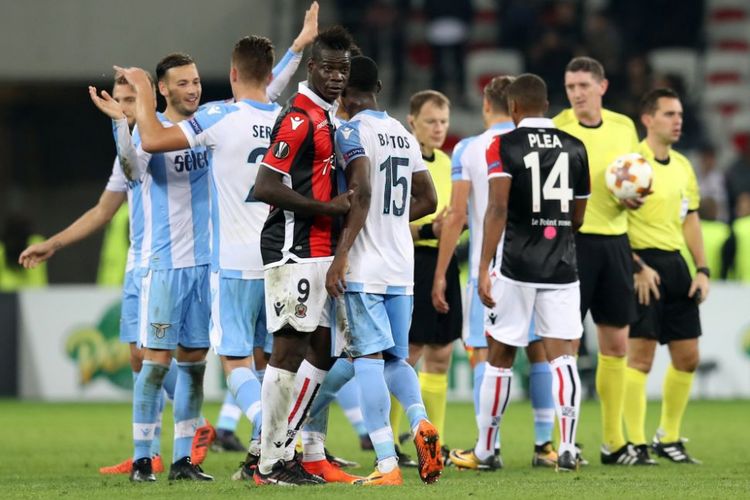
[138,265,211,350]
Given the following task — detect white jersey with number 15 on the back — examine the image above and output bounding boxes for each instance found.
[336,110,427,295]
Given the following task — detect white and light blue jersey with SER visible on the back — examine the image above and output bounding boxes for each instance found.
[179,99,281,279]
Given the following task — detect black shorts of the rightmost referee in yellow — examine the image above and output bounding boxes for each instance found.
[630,249,701,344]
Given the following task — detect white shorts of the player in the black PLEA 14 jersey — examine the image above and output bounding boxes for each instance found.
[484,278,583,347]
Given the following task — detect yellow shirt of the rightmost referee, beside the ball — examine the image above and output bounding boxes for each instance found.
[628,140,700,250]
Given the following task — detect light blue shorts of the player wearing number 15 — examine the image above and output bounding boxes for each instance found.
[344,292,414,359]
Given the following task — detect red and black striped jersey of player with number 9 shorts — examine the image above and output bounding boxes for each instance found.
[260,83,336,268]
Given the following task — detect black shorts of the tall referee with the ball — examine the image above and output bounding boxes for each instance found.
[576,233,636,326]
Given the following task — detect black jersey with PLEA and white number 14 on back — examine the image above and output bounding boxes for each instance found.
[487,118,590,288]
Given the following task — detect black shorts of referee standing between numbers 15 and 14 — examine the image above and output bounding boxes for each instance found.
[409,247,463,345]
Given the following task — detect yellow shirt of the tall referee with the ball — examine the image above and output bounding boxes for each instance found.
[553,109,638,235]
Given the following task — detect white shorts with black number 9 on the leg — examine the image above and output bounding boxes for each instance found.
[264,261,331,333]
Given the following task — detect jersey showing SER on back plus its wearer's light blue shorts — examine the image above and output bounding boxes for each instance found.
[179,99,281,356]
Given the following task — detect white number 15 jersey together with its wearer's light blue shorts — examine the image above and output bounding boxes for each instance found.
[336,110,427,358]
